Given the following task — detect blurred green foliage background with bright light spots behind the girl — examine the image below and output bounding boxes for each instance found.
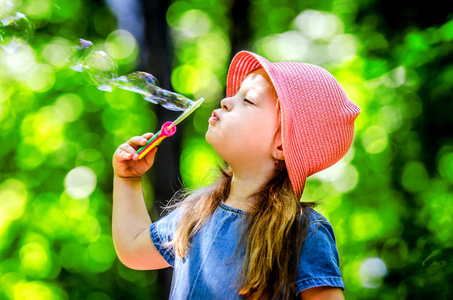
[0,0,453,299]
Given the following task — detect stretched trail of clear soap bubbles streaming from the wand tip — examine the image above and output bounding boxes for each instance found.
[67,39,195,111]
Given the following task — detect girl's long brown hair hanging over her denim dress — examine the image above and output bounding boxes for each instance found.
[165,167,315,299]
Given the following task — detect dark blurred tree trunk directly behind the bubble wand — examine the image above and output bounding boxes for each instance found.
[141,0,177,299]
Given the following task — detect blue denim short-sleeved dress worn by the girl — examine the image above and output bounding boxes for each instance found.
[150,202,344,300]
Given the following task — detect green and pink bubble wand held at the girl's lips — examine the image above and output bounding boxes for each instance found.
[137,98,204,159]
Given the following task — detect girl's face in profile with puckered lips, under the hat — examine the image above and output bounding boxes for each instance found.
[206,69,280,170]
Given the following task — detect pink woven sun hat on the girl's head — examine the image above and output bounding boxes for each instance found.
[227,51,360,197]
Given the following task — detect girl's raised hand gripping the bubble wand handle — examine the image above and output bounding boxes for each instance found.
[112,133,157,180]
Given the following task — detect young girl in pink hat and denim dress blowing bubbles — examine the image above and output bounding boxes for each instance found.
[113,51,360,299]
